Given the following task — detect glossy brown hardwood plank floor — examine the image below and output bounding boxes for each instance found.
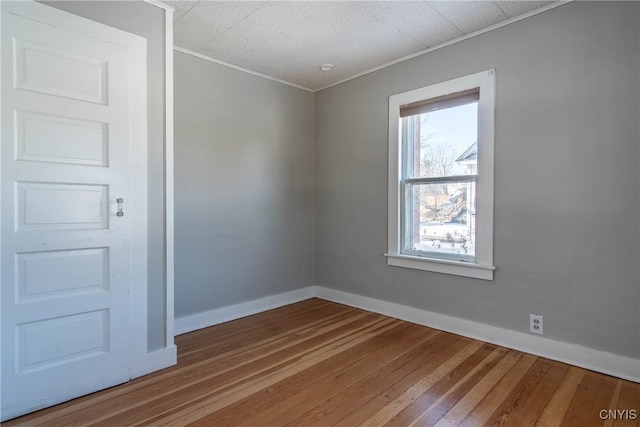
[3,299,640,427]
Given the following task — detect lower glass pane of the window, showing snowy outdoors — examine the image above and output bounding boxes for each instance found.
[404,182,476,261]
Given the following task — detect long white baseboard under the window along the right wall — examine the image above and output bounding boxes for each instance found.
[314,286,640,383]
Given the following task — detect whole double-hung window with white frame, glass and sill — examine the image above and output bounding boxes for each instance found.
[386,70,495,280]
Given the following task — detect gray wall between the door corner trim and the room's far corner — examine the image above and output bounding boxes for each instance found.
[175,52,314,317]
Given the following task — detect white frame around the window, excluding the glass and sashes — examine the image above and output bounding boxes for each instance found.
[385,69,496,280]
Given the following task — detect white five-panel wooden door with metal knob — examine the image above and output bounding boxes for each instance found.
[0,2,146,419]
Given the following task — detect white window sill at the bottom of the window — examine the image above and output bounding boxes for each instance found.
[384,254,496,280]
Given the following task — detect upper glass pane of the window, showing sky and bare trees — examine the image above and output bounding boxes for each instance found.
[402,102,478,178]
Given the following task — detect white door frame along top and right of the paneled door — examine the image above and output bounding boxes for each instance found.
[0,1,150,378]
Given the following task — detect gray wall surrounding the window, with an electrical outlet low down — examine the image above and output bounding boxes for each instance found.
[315,2,640,358]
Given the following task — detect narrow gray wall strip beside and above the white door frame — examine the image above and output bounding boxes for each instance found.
[43,1,166,350]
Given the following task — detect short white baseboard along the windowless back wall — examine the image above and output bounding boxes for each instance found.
[175,286,315,335]
